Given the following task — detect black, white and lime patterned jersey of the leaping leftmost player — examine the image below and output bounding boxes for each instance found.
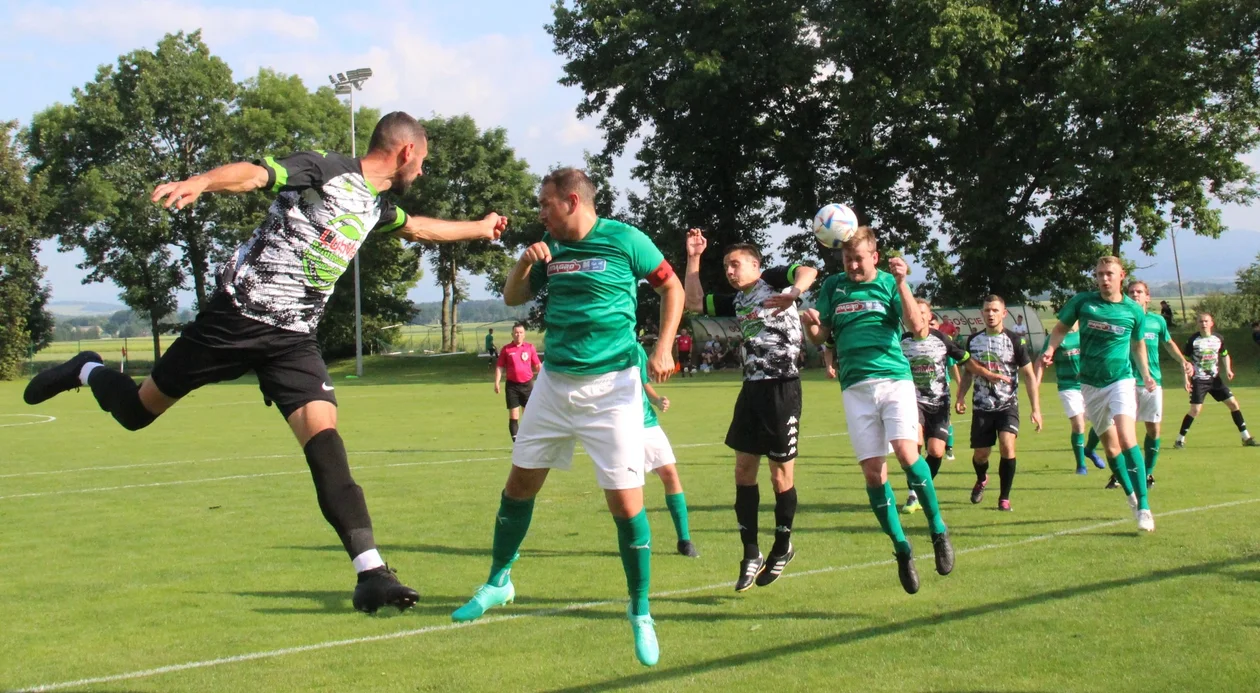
[218,151,407,333]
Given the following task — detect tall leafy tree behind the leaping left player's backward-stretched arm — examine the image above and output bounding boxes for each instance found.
[26,32,236,330]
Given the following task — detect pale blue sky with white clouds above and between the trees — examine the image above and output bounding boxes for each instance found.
[0,0,1260,305]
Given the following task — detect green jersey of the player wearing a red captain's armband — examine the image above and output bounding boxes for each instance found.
[529,219,665,375]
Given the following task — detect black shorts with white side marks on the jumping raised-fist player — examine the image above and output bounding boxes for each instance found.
[726,378,800,462]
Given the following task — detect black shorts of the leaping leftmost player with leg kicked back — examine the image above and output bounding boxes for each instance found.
[152,294,336,418]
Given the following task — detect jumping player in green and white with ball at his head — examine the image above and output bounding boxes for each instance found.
[801,227,954,595]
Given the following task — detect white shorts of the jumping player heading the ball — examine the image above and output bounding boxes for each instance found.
[840,378,919,462]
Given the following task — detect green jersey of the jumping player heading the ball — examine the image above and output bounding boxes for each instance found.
[814,270,914,389]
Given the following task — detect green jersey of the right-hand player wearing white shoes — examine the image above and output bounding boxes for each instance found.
[1058,291,1145,387]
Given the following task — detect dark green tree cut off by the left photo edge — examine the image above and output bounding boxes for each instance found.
[0,122,53,381]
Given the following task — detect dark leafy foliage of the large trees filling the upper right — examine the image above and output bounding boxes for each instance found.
[548,0,1260,302]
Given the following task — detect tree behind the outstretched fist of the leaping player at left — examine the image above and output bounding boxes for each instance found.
[401,116,538,352]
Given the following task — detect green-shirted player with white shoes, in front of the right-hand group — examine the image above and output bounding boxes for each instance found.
[1042,256,1157,532]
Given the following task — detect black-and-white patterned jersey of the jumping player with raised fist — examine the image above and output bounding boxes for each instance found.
[704,265,804,381]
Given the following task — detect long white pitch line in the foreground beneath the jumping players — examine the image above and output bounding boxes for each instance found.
[10,498,1260,693]
